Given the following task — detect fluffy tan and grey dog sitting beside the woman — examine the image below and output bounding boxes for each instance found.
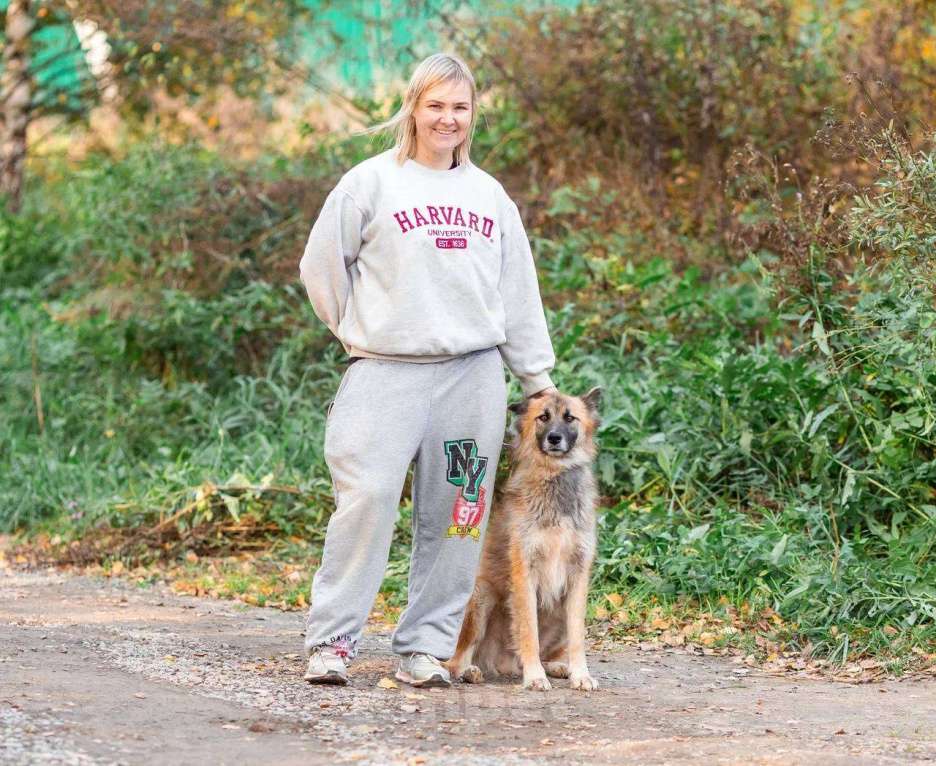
[448,388,601,691]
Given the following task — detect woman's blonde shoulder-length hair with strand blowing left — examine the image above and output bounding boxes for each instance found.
[360,53,478,165]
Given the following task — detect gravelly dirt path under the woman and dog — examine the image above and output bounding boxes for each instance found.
[0,570,936,766]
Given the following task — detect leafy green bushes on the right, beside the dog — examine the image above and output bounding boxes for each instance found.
[536,123,936,657]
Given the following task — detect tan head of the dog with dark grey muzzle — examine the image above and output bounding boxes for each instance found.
[510,388,601,463]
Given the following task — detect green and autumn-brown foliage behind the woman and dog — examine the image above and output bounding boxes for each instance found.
[0,0,936,671]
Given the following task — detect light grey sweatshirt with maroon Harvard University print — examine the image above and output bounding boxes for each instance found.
[299,148,555,396]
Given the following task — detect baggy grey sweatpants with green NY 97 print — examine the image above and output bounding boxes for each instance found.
[305,348,507,659]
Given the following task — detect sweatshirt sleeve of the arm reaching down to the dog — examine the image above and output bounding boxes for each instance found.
[499,198,556,396]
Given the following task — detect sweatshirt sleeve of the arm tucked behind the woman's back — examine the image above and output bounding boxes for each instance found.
[299,188,364,335]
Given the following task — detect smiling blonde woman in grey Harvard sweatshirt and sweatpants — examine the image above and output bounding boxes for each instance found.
[299,54,555,686]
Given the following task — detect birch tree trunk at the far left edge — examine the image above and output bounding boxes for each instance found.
[0,0,35,212]
